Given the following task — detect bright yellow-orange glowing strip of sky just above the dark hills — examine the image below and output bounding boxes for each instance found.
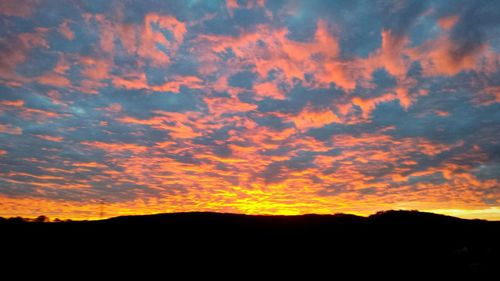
[0,194,500,221]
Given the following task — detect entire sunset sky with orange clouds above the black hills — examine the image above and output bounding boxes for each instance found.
[0,0,500,220]
